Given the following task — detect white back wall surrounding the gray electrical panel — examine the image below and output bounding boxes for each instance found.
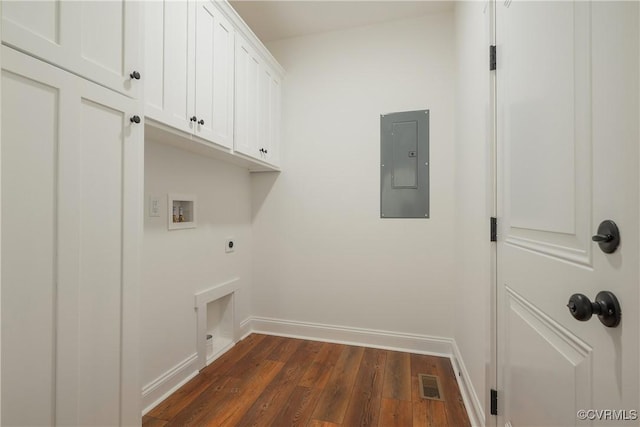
[251,12,458,337]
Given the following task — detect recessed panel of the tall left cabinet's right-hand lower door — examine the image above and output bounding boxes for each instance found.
[77,91,127,426]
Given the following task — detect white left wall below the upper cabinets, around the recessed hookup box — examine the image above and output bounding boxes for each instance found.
[141,140,252,407]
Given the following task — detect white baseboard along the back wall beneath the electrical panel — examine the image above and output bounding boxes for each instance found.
[249,317,453,357]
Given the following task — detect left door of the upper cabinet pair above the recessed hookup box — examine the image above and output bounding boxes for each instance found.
[144,0,195,133]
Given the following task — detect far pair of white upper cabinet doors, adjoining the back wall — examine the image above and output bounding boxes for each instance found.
[234,35,281,166]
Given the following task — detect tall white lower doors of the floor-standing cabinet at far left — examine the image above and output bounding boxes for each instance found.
[1,47,142,425]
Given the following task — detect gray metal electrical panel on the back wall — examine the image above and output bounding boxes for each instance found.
[380,110,429,218]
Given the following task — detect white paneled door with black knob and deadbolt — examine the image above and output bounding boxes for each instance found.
[496,1,640,427]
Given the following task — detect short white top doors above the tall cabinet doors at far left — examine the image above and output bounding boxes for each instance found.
[1,0,144,98]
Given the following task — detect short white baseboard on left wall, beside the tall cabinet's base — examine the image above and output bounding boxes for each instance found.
[142,353,199,415]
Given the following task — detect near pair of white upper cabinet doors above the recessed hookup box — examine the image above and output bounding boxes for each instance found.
[144,0,234,148]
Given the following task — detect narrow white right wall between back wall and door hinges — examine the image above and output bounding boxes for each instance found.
[454,2,494,422]
